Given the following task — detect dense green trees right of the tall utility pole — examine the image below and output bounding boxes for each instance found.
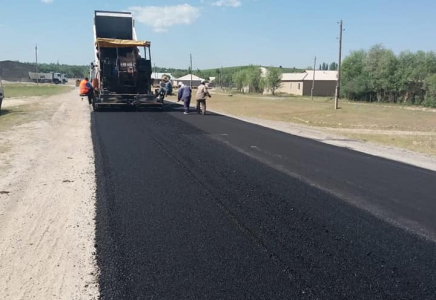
[341,44,436,107]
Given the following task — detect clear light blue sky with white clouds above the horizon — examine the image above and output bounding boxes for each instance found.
[0,0,436,69]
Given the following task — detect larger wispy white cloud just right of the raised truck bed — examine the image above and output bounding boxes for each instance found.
[129,4,200,32]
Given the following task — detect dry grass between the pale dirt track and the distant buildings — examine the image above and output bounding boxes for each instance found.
[208,94,436,131]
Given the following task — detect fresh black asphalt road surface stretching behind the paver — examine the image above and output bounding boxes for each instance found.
[92,107,436,299]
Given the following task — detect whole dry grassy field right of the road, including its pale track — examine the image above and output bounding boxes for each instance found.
[169,93,436,155]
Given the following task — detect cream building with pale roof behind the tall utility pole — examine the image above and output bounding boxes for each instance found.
[276,70,338,96]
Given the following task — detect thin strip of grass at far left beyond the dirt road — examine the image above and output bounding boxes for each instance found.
[4,83,73,98]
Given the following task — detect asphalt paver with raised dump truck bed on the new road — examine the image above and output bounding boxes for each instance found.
[90,11,160,111]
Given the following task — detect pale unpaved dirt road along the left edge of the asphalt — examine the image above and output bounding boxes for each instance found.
[0,91,98,300]
